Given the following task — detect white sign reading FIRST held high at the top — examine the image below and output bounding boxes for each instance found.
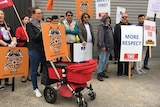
[96,0,110,19]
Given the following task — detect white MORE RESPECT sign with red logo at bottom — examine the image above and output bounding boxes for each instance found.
[120,25,143,62]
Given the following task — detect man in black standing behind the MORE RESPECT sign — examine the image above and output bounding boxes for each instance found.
[114,13,132,77]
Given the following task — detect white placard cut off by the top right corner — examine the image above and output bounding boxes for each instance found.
[147,0,160,18]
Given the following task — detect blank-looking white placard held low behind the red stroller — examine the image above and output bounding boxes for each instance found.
[73,43,92,62]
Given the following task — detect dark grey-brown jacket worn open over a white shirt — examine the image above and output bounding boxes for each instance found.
[78,23,95,45]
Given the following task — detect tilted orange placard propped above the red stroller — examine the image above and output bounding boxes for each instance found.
[42,23,68,60]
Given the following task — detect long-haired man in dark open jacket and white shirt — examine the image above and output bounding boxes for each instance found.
[78,13,95,46]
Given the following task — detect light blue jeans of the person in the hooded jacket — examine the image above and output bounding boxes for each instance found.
[97,51,110,73]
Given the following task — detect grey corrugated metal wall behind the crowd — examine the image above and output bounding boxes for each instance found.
[35,0,160,58]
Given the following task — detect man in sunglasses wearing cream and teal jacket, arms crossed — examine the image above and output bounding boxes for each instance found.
[63,11,78,43]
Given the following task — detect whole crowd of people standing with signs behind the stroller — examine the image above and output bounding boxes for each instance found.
[0,7,149,97]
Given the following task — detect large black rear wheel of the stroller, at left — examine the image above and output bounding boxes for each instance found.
[44,86,57,104]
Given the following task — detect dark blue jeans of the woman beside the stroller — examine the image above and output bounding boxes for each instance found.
[29,50,43,90]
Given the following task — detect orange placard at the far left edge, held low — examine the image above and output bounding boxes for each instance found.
[0,47,29,78]
